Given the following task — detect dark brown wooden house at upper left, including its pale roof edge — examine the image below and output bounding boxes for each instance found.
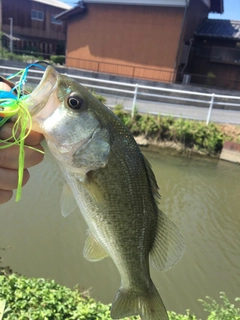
[0,0,71,58]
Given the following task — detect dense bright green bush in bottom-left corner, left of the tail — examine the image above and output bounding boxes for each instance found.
[0,274,138,320]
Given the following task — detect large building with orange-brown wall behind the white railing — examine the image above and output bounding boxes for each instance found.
[56,0,223,82]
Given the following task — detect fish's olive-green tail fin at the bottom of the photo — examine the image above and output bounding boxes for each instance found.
[111,283,169,320]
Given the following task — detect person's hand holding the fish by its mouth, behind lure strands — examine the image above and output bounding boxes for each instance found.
[0,82,43,204]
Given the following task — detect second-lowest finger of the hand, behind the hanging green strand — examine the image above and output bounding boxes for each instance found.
[0,168,30,191]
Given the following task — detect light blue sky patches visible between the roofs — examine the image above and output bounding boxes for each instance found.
[60,0,240,20]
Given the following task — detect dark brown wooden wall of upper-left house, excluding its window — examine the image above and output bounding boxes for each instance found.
[2,0,66,54]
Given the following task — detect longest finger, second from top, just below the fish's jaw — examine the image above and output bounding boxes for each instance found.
[0,144,44,169]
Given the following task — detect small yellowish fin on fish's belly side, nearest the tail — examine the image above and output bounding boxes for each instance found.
[83,232,108,261]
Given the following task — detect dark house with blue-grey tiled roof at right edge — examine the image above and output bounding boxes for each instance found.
[186,19,240,90]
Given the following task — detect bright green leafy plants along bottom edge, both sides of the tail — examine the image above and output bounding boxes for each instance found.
[0,272,240,320]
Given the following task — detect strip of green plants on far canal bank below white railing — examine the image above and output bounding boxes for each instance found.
[114,105,229,154]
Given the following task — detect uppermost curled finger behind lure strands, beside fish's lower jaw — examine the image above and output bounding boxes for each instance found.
[0,122,44,146]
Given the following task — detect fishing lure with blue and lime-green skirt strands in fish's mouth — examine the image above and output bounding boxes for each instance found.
[0,61,48,202]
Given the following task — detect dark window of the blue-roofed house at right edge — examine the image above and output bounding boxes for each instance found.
[210,47,240,65]
